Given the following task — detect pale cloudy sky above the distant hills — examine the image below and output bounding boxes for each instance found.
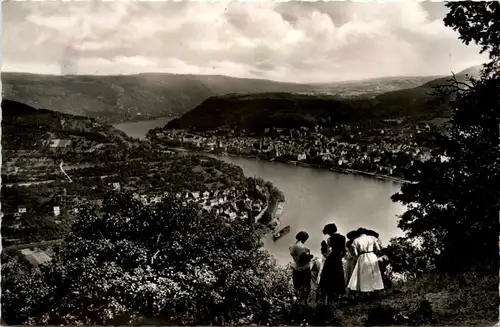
[2,1,484,83]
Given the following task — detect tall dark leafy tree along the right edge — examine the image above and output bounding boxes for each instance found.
[392,2,500,271]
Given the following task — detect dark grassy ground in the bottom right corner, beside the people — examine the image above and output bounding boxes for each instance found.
[338,273,500,326]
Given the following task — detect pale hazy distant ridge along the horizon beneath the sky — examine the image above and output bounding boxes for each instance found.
[2,72,450,123]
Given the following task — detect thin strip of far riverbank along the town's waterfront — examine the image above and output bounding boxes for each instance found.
[169,147,411,184]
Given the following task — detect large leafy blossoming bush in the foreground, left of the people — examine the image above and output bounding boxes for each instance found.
[1,192,292,325]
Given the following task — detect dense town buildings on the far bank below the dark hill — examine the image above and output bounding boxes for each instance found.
[156,124,442,179]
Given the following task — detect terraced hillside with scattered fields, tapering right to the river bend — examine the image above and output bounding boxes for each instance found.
[1,99,282,246]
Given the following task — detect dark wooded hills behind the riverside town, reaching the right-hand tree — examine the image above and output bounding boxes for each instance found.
[167,68,484,130]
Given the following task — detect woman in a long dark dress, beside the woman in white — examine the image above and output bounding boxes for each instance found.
[319,224,346,304]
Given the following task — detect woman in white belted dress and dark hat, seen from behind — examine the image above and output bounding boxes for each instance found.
[347,228,384,294]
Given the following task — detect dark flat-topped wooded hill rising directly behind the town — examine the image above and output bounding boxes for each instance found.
[167,93,374,130]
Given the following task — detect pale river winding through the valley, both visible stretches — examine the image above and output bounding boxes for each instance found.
[115,119,404,263]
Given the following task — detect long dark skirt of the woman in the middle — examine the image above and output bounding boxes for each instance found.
[319,257,345,296]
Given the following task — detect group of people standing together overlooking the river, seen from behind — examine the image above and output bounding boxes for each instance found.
[290,223,388,304]
